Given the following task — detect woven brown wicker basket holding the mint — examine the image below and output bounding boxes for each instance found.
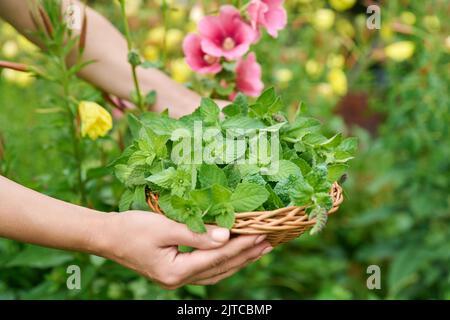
[147,182,344,247]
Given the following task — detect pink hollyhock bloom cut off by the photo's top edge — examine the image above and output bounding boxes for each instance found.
[247,0,287,38]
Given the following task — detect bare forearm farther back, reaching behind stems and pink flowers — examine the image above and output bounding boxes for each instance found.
[0,0,200,116]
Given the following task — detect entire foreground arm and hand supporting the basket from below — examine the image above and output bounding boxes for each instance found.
[0,176,270,289]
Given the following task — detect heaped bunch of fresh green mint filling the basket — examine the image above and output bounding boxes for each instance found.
[114,89,357,234]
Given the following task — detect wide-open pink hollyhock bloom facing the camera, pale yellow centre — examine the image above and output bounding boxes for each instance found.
[199,6,255,60]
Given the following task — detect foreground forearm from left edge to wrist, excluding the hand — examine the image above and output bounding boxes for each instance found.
[0,176,105,253]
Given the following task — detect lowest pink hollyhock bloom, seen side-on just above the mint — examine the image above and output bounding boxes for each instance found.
[236,52,264,97]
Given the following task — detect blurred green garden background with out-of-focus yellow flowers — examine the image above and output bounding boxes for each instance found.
[0,0,450,299]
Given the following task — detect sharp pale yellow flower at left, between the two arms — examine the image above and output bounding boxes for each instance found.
[78,101,112,140]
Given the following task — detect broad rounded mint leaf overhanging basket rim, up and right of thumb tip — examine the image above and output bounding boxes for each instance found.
[230,183,269,212]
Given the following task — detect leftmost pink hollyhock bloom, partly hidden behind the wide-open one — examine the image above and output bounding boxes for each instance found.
[183,33,222,74]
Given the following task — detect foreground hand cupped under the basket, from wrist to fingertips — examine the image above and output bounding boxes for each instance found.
[98,211,272,289]
